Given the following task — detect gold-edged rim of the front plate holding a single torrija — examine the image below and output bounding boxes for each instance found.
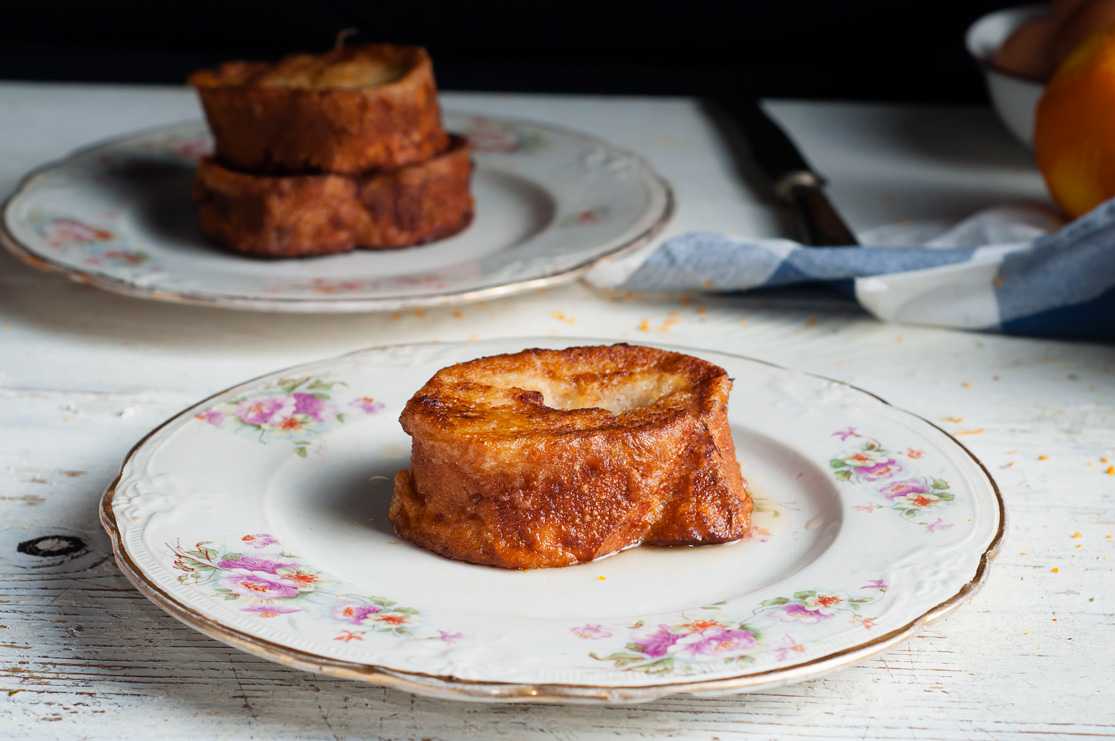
[98,335,1007,703]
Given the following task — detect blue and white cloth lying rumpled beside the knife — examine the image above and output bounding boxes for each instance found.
[589,201,1115,340]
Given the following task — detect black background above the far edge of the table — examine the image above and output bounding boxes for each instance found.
[0,0,1017,101]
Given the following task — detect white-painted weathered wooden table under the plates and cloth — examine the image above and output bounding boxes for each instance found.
[0,84,1115,740]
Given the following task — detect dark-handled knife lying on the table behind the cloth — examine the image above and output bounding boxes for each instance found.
[716,99,857,247]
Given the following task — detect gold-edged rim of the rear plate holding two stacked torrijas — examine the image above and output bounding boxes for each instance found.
[0,108,677,314]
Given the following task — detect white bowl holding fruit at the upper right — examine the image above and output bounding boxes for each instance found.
[967,4,1049,147]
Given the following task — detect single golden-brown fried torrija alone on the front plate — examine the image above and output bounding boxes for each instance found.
[389,344,752,568]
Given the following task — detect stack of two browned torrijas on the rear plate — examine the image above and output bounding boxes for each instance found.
[190,43,473,257]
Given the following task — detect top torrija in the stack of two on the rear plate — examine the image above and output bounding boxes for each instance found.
[188,43,447,174]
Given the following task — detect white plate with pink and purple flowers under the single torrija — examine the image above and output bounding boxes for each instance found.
[101,338,1004,702]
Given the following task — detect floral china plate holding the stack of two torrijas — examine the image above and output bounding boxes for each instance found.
[0,113,672,312]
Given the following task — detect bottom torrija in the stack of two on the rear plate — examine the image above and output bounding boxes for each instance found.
[194,137,473,257]
